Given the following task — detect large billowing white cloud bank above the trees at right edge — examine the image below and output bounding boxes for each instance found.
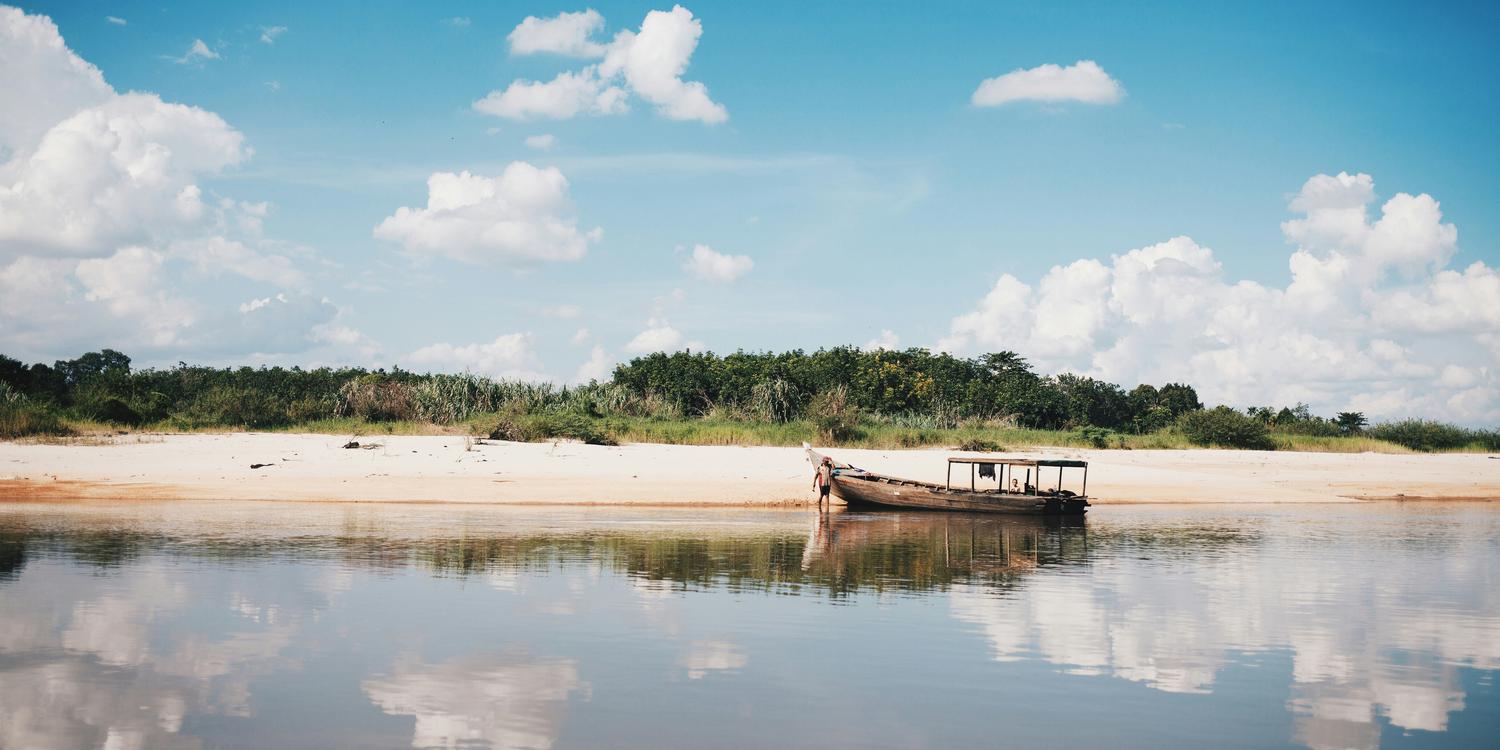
[938,174,1500,423]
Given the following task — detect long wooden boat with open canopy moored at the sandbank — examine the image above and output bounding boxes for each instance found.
[803,443,1089,516]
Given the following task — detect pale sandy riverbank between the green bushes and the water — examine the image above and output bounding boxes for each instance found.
[0,434,1500,506]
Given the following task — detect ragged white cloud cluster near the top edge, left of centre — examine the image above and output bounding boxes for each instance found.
[474,6,729,125]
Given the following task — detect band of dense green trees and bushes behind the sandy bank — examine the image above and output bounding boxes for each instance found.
[0,347,1500,450]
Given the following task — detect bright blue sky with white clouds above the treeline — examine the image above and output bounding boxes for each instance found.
[0,2,1500,425]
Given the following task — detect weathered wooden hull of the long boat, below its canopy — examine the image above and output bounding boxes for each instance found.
[833,474,1089,516]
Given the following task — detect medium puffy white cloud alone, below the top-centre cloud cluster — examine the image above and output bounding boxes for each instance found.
[375,162,603,264]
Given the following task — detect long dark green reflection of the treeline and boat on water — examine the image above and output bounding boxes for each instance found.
[0,509,1278,596]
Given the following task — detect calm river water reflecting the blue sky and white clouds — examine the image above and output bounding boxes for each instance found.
[0,503,1500,749]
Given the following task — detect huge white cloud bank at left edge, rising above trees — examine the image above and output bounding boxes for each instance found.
[0,8,339,359]
